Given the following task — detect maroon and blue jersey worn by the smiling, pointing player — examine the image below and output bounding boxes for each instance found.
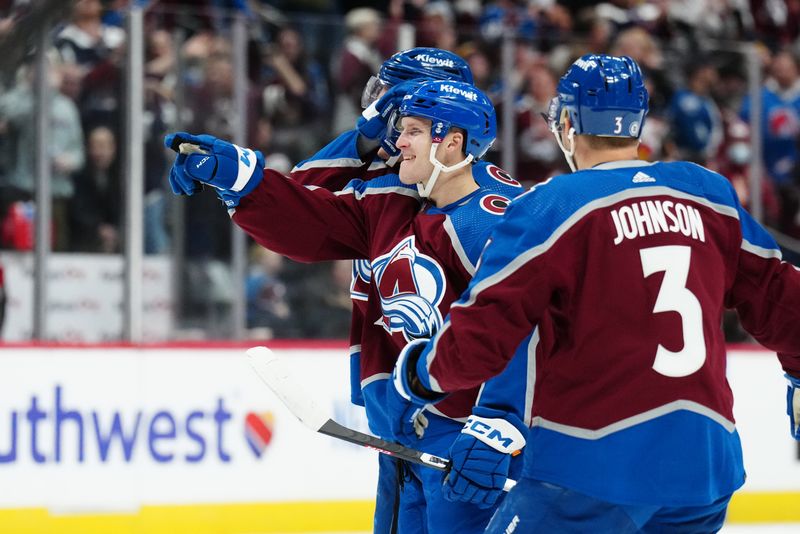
[228,170,520,435]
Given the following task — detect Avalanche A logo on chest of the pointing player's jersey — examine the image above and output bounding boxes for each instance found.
[372,236,445,341]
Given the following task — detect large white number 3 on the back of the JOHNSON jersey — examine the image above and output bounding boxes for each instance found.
[639,245,706,378]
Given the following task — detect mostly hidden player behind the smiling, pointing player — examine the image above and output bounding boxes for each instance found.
[291,47,523,533]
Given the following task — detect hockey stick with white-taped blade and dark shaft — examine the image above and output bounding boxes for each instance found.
[247,347,516,491]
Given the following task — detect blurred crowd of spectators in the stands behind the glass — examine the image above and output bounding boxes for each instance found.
[0,0,800,341]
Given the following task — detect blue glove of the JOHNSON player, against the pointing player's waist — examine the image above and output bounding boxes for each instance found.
[386,339,444,445]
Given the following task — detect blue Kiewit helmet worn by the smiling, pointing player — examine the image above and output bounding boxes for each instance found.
[398,80,497,160]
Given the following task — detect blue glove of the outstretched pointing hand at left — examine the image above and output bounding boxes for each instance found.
[164,132,264,207]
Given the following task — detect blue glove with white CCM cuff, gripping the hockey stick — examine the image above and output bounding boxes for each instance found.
[443,406,528,508]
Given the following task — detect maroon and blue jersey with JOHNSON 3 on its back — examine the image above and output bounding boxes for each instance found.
[419,161,800,506]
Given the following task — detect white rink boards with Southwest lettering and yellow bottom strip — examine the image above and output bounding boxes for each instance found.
[0,344,800,533]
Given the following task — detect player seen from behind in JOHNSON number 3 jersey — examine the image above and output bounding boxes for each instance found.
[390,55,800,533]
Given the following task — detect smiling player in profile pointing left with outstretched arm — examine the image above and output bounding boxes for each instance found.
[166,81,528,533]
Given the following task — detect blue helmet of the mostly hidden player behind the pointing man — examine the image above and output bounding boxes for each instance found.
[361,47,473,108]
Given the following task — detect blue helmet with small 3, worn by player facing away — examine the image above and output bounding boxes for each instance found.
[547,54,648,139]
